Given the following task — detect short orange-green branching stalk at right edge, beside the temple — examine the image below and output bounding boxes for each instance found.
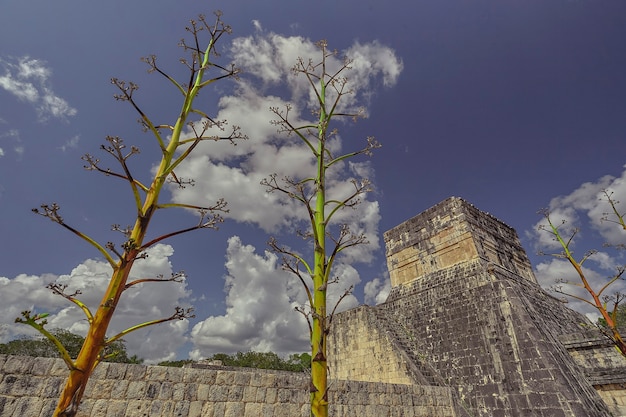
[539,190,626,357]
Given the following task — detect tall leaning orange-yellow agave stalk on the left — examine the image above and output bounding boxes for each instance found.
[17,12,243,417]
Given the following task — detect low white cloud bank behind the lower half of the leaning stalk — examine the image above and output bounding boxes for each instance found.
[0,244,190,363]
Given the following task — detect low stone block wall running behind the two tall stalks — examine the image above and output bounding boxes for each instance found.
[0,355,457,417]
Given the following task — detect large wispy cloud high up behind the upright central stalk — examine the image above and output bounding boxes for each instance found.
[171,33,402,262]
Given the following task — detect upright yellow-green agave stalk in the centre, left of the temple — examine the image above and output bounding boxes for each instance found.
[262,41,379,417]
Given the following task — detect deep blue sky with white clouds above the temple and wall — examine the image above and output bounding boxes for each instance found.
[0,0,626,363]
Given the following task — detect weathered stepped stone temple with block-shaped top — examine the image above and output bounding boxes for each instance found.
[329,197,626,417]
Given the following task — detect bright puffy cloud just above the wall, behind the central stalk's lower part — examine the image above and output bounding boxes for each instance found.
[190,236,360,359]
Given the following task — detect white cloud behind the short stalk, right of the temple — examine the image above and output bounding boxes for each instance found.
[527,165,626,320]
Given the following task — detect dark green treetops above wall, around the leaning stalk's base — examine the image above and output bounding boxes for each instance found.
[0,329,143,363]
